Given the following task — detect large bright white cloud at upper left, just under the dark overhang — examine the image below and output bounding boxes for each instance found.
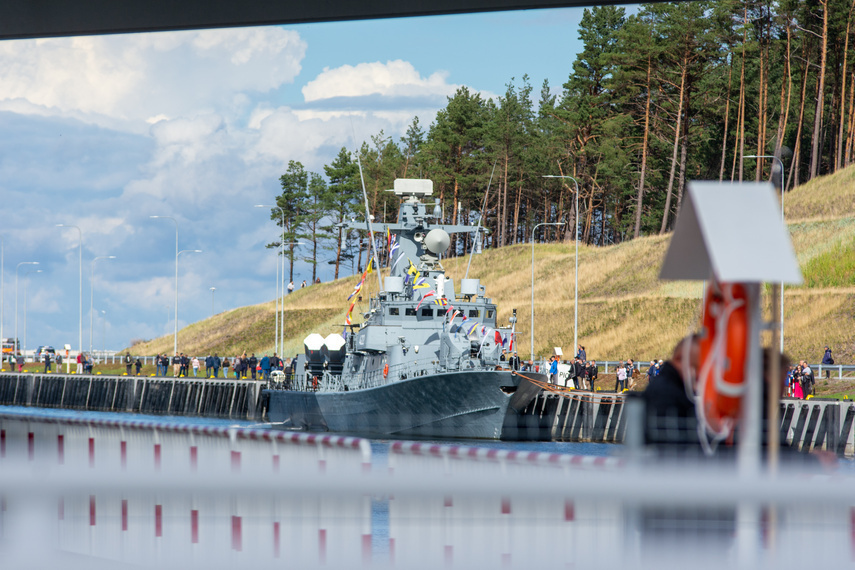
[0,27,306,129]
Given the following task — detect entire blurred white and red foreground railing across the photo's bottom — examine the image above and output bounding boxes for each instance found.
[0,410,855,570]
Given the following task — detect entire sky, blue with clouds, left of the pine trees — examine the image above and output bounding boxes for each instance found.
[0,8,628,350]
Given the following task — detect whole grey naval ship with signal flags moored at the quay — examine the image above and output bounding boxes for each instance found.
[263,179,546,439]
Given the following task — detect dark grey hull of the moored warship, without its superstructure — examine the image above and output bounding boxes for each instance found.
[266,370,545,439]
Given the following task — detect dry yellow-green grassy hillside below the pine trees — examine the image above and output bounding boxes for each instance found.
[131,167,855,363]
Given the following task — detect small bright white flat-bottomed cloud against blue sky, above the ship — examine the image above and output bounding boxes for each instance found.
[303,59,458,102]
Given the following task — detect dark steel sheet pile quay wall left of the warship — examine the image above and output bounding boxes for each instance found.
[0,373,262,419]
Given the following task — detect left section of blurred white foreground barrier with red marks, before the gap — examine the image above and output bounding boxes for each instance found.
[0,415,371,568]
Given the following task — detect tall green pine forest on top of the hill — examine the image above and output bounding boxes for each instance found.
[269,0,855,280]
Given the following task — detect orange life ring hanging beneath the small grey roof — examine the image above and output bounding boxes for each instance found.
[698,282,748,436]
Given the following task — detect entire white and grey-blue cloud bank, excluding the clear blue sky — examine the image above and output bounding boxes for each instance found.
[0,28,478,348]
